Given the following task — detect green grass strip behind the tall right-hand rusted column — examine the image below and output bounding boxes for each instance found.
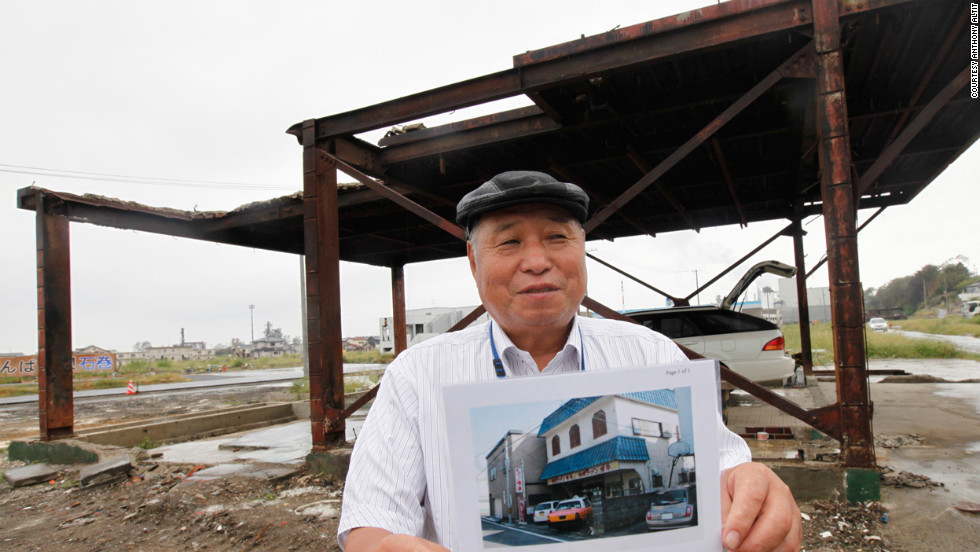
[782,321,980,366]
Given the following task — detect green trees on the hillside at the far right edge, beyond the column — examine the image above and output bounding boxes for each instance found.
[864,255,980,316]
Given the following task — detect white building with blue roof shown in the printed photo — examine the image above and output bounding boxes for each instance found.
[538,390,694,498]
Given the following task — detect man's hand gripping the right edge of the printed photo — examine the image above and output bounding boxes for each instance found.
[721,462,803,552]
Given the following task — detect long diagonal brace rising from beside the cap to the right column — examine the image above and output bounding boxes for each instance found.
[584,44,813,233]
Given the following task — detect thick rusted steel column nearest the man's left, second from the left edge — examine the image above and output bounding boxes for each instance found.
[303,120,345,452]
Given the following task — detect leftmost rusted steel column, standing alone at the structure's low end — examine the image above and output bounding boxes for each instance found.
[34,191,75,441]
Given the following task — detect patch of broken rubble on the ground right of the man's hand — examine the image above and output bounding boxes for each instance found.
[800,500,901,552]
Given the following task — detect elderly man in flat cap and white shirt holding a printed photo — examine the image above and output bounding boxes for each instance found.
[338,171,801,552]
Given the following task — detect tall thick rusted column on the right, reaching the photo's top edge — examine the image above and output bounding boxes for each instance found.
[813,0,875,468]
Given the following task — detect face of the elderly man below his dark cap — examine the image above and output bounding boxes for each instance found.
[466,203,587,336]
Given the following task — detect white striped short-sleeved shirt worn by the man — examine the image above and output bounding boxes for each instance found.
[337,316,751,547]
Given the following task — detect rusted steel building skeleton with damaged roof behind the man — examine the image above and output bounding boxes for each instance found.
[18,0,980,500]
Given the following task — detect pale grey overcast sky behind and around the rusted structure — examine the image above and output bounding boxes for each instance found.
[0,0,980,353]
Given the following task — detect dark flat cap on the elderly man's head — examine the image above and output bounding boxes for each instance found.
[456,171,589,229]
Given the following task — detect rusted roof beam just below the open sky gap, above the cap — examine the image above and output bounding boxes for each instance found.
[380,114,561,165]
